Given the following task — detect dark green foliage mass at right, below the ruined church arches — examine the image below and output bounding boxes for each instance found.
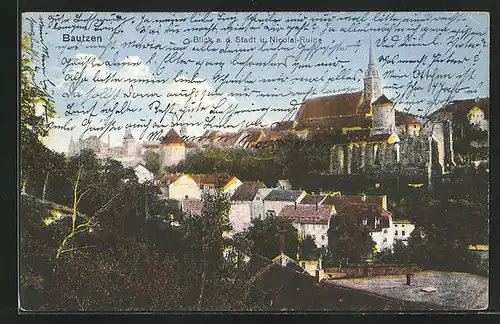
[376,168,489,272]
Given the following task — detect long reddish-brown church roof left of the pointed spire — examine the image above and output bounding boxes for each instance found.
[296,91,363,121]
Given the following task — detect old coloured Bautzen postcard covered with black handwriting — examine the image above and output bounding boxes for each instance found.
[19,12,490,313]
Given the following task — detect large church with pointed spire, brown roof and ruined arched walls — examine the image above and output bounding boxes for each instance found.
[293,44,454,181]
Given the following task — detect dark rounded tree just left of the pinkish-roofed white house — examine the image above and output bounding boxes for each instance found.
[245,216,299,259]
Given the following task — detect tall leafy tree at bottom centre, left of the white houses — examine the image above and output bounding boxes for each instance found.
[179,191,258,310]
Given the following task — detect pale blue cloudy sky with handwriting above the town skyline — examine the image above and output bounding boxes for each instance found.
[23,12,489,152]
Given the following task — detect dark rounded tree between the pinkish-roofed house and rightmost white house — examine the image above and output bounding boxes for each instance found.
[328,217,375,264]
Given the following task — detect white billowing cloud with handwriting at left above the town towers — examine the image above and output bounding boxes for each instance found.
[46,53,237,151]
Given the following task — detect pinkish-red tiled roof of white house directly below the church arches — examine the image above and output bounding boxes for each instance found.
[278,204,333,224]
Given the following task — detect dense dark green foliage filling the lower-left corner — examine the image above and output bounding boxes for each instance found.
[21,158,254,311]
